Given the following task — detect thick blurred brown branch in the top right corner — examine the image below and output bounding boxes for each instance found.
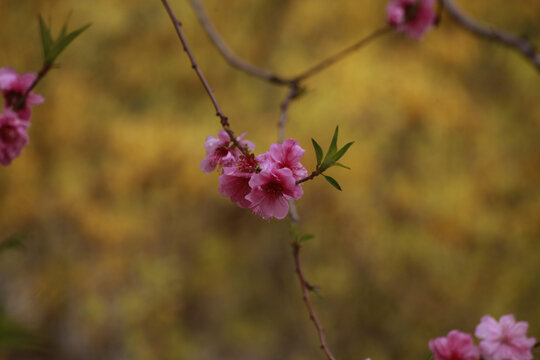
[441,0,540,71]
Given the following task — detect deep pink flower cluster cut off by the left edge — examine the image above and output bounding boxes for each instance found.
[0,67,44,166]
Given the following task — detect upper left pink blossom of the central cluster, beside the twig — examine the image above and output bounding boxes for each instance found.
[201,130,255,174]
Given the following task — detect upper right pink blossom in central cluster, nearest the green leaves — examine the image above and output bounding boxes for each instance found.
[257,139,308,180]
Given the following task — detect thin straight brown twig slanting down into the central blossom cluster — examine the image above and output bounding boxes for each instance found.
[161,0,249,156]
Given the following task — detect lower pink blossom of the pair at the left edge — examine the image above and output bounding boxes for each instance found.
[0,110,28,166]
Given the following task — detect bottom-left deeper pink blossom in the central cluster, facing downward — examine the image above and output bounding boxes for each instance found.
[219,155,258,208]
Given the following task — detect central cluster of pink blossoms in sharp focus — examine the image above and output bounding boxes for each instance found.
[201,130,308,220]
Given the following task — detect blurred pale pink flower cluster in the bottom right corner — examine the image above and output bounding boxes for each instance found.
[429,315,536,360]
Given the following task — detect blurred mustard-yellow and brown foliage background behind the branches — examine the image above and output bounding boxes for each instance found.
[0,0,540,360]
